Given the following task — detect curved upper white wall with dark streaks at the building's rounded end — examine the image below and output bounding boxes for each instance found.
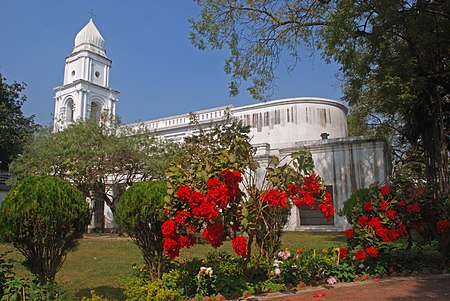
[232,98,348,147]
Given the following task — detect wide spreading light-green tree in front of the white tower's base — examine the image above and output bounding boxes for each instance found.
[11,121,176,228]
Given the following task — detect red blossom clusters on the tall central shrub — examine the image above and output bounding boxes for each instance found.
[161,159,334,259]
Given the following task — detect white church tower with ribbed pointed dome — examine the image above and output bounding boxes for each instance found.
[53,19,119,130]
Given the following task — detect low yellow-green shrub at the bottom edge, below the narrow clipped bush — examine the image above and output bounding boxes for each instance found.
[124,279,183,301]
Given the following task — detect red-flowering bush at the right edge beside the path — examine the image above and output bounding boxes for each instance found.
[340,177,450,274]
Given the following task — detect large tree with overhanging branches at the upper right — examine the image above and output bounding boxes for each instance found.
[191,0,450,195]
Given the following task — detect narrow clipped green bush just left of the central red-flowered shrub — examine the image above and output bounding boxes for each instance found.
[115,181,167,280]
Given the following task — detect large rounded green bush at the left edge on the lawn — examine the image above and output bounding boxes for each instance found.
[0,176,91,284]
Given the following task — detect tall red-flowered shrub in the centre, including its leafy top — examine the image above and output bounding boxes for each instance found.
[162,120,334,269]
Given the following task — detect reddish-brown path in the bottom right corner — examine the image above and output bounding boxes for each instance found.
[245,274,450,301]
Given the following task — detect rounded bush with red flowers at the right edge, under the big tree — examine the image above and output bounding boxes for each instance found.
[340,178,450,266]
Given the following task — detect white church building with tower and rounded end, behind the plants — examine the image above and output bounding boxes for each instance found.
[54,20,390,231]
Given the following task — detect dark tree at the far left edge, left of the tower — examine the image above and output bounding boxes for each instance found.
[0,73,36,171]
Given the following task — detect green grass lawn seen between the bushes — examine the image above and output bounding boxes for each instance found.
[0,232,345,300]
